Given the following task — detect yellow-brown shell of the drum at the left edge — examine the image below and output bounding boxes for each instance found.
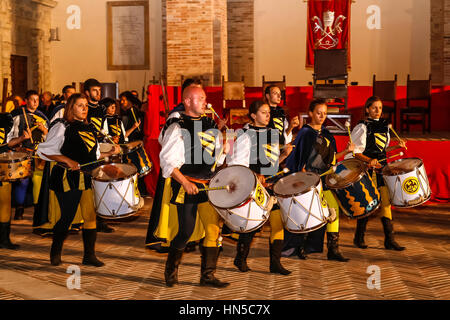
[0,152,33,182]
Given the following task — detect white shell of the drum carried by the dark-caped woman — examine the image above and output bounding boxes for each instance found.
[275,179,330,233]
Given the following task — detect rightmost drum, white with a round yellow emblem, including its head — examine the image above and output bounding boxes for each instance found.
[382,158,431,208]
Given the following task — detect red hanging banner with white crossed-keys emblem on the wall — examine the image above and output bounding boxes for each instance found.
[306,0,351,67]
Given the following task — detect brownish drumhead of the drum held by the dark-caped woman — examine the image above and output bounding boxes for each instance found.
[273,172,320,197]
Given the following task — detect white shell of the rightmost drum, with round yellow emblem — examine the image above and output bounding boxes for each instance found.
[383,159,431,208]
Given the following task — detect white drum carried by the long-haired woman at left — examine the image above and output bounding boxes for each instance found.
[92,163,143,219]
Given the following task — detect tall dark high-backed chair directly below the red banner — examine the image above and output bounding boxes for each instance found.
[313,49,348,112]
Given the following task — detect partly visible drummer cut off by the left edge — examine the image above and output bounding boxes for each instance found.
[0,113,31,250]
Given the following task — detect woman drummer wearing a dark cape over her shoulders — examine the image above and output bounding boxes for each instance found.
[284,99,354,262]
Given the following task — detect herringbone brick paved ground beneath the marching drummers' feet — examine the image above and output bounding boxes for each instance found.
[0,198,450,300]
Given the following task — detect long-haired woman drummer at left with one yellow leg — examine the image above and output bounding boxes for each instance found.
[37,93,120,267]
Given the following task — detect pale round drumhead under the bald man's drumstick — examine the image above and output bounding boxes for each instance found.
[208,165,256,209]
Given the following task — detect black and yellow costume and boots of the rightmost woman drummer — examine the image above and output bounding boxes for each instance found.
[351,118,405,251]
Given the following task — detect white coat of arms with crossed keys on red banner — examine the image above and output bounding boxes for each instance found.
[312,11,346,49]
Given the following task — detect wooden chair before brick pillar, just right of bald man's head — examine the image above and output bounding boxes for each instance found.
[222,76,248,125]
